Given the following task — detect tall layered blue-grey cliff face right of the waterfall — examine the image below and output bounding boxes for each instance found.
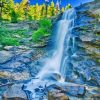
[61,1,100,100]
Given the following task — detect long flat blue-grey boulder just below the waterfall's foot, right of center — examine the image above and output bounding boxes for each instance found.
[48,83,86,96]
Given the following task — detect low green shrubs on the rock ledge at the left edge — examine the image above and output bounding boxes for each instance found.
[0,28,26,46]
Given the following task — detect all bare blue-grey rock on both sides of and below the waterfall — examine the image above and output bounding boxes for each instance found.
[0,2,100,100]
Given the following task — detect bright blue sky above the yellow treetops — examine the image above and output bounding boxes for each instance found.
[14,0,93,7]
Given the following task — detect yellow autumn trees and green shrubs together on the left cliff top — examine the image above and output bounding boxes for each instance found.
[0,0,71,46]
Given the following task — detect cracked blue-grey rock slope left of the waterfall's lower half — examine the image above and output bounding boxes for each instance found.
[0,46,46,100]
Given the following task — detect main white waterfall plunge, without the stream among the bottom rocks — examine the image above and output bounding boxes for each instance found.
[37,9,76,79]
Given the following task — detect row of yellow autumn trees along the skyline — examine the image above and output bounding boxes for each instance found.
[0,0,72,20]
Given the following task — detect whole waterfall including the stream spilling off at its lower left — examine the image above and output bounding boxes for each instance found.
[23,9,76,100]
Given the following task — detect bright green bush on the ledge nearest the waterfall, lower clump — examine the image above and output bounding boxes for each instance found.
[32,28,50,43]
